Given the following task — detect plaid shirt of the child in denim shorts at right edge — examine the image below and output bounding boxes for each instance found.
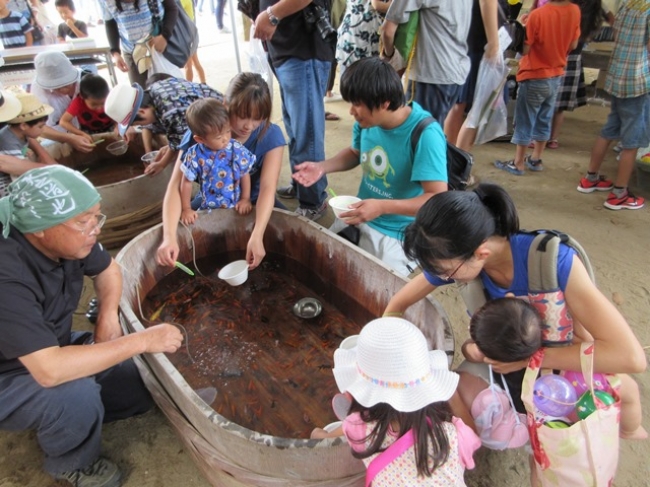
[605,0,650,98]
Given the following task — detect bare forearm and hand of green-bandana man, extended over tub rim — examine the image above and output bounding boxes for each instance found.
[19,323,183,387]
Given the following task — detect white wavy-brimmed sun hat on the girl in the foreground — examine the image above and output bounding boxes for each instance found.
[333,318,458,413]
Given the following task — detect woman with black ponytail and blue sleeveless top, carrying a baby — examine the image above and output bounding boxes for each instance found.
[385,184,646,438]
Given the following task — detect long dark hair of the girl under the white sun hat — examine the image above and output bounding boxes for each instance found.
[350,399,451,477]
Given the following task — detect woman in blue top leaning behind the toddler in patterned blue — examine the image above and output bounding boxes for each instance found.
[157,73,286,269]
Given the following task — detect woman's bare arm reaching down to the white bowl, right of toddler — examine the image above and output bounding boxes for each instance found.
[246,146,284,269]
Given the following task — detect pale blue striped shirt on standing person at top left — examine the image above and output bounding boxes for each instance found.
[99,0,165,54]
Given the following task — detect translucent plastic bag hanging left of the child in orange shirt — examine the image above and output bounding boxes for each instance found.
[466,56,510,145]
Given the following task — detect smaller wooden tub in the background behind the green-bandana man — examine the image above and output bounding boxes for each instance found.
[46,133,173,248]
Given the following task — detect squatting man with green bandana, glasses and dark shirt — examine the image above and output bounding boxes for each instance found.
[0,165,183,487]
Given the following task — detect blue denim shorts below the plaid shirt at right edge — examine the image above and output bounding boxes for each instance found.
[600,93,650,149]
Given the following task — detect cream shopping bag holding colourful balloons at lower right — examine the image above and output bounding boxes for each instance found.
[521,342,621,487]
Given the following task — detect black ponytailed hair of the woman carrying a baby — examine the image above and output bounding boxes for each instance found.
[403,184,519,274]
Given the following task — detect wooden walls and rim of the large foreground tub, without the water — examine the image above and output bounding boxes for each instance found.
[117,210,454,487]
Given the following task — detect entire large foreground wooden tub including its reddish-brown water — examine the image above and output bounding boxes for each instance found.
[117,210,454,487]
